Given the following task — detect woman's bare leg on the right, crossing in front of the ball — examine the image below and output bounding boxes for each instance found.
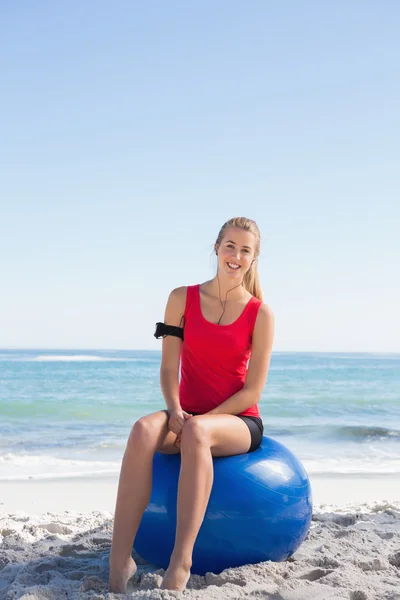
[162,415,251,591]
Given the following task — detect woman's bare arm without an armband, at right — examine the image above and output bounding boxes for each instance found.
[207,304,274,415]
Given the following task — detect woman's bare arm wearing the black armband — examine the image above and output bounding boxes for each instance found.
[160,287,188,434]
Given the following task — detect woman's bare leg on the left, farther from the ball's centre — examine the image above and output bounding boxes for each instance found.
[109,411,179,593]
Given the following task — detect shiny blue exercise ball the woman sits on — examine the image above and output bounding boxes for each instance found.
[134,436,312,575]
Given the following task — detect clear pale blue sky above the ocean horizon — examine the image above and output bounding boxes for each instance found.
[0,0,400,352]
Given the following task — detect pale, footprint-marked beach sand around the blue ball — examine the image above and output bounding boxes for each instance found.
[0,475,400,600]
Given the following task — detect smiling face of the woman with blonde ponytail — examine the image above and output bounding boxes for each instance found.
[216,227,256,279]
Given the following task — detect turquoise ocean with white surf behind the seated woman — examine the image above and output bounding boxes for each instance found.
[0,350,400,481]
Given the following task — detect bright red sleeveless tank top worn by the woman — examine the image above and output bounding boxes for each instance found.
[179,284,261,417]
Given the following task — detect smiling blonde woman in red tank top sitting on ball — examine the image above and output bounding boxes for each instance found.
[109,217,274,593]
